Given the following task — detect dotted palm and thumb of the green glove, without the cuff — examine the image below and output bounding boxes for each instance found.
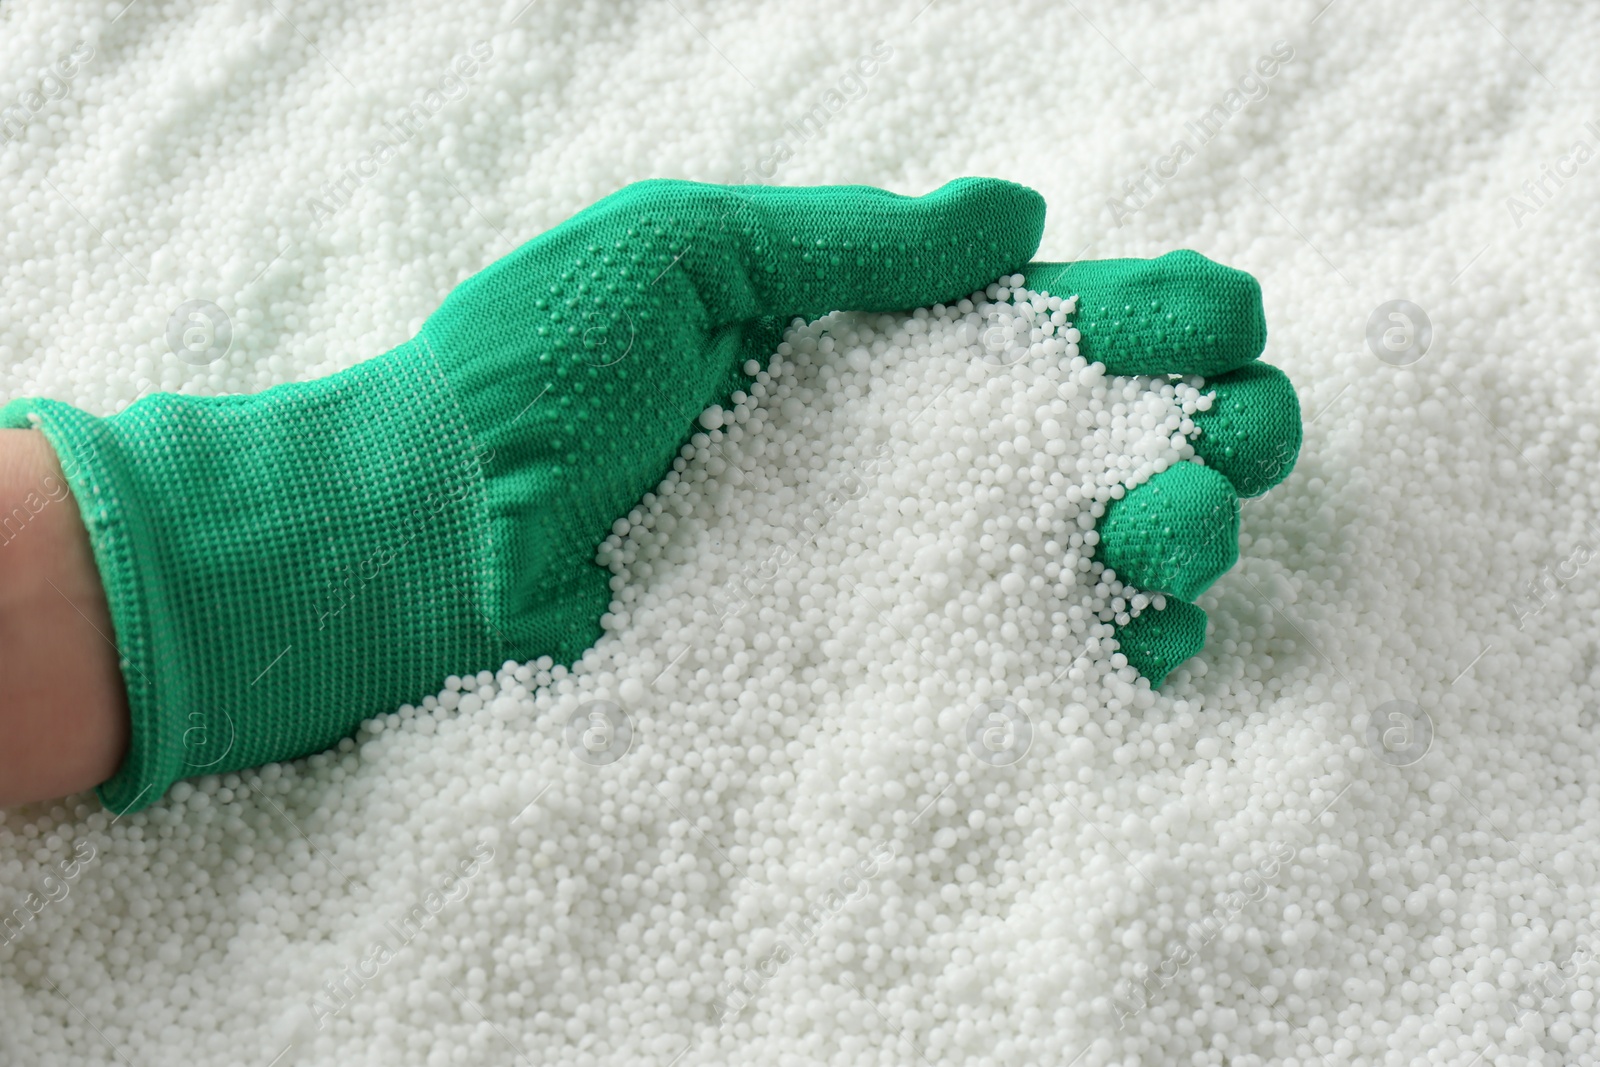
[419,179,1045,662]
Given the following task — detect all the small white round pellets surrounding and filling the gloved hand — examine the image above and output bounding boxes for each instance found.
[0,0,1600,1067]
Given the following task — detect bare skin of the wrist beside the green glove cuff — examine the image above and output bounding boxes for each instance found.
[0,430,128,805]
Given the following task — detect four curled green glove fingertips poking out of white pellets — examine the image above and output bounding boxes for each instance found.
[1024,251,1301,686]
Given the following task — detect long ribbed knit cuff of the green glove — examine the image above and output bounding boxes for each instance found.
[0,344,506,813]
